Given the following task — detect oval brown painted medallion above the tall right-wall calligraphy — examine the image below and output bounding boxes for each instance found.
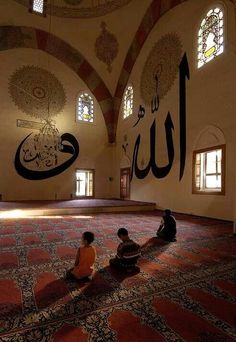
[140,33,182,104]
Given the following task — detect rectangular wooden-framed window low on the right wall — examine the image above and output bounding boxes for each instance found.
[193,146,225,195]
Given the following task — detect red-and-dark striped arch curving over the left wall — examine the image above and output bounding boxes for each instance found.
[0,26,115,142]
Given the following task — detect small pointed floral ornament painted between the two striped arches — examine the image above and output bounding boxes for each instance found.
[95,21,119,72]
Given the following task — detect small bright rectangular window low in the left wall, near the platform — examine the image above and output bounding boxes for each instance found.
[75,170,94,197]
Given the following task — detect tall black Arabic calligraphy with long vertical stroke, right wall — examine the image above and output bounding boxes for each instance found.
[131,53,190,181]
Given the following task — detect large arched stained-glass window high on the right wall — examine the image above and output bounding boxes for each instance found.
[198,7,224,68]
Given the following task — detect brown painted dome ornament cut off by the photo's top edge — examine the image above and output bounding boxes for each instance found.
[14,0,132,18]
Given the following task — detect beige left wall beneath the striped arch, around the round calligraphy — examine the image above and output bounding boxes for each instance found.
[0,49,111,201]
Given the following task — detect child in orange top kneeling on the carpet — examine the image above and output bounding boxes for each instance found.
[66,232,96,280]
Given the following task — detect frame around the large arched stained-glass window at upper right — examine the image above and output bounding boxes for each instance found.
[195,5,224,70]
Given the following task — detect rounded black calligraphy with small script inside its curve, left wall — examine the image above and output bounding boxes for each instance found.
[15,133,79,180]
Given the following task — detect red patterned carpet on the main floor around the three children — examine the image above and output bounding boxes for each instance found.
[0,211,236,342]
